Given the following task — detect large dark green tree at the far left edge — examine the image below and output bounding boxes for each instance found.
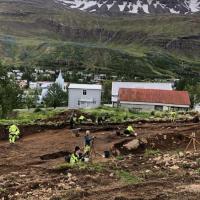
[0,63,23,118]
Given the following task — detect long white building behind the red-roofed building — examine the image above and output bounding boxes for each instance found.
[111,82,173,106]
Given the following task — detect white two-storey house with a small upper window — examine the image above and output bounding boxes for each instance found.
[68,84,102,108]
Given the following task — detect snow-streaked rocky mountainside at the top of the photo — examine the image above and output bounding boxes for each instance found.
[56,0,200,14]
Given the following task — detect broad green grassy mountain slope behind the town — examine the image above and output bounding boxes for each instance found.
[0,1,200,78]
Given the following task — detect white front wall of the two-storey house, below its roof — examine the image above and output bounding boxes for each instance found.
[68,88,101,108]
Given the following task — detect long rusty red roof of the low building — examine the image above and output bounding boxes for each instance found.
[119,88,190,105]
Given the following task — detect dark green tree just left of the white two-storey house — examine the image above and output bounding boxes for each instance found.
[44,83,67,108]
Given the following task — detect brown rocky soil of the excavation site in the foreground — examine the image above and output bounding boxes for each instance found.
[0,122,200,200]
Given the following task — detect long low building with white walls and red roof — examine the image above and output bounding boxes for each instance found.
[118,88,190,111]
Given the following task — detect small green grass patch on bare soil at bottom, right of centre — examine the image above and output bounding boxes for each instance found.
[116,170,142,185]
